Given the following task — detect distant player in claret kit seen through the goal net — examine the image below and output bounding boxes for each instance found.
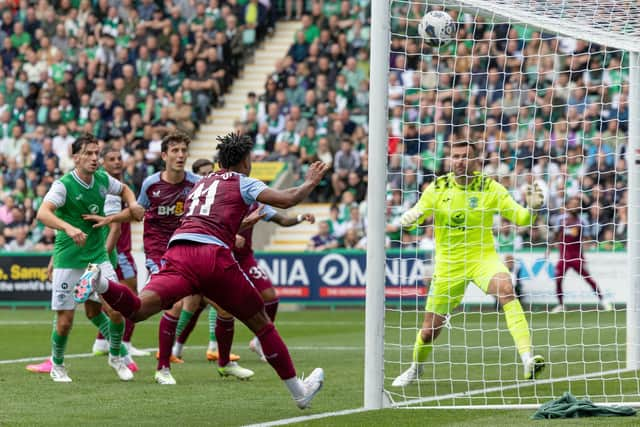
[551,197,612,313]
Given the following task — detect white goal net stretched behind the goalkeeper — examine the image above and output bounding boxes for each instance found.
[372,0,640,407]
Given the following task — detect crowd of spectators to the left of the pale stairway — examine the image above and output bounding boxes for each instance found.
[0,0,277,251]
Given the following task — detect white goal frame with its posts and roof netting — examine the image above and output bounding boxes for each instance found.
[364,0,640,409]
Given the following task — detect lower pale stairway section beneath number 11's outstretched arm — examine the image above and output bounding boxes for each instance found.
[264,203,331,252]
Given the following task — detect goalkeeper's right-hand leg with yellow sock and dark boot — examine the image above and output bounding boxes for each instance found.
[488,267,545,380]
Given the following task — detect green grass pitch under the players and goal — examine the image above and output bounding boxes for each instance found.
[0,310,640,426]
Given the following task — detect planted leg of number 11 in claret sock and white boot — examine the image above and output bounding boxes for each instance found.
[200,245,324,409]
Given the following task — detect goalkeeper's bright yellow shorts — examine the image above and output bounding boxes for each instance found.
[425,253,510,315]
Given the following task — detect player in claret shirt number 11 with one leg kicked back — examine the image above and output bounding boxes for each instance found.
[74,133,329,409]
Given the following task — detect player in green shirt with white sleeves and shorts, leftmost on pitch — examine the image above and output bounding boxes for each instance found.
[29,134,144,382]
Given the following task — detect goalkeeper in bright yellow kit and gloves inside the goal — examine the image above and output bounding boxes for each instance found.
[392,141,545,387]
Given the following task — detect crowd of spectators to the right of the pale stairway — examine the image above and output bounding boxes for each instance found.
[296,6,629,252]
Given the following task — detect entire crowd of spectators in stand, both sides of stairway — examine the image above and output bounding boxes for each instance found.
[0,0,629,254]
